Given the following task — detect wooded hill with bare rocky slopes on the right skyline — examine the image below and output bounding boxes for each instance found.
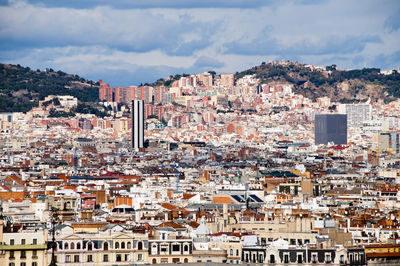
[236,62,400,102]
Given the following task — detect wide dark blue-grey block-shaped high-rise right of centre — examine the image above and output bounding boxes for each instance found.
[315,114,347,145]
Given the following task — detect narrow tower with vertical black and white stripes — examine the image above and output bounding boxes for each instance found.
[132,100,144,151]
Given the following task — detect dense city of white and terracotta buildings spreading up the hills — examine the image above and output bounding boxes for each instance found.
[0,61,400,266]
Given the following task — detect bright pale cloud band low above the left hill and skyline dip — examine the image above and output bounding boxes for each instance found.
[0,46,224,86]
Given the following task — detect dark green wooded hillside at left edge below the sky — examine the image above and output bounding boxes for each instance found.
[0,64,99,112]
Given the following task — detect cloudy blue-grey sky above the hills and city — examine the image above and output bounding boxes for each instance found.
[0,0,400,86]
